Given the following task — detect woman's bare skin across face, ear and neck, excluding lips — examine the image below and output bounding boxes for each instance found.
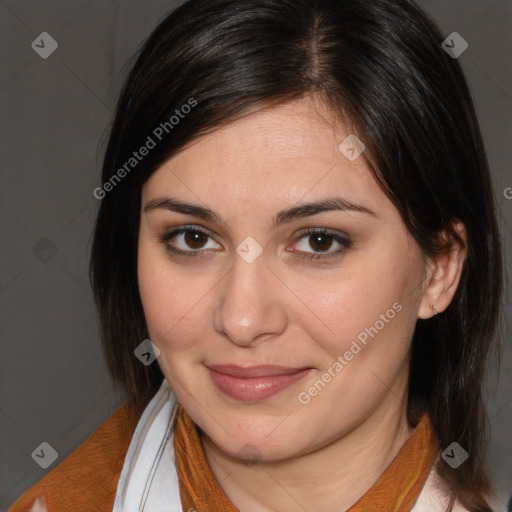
[138,98,464,512]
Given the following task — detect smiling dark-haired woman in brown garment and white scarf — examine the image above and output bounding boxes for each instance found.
[11,0,501,512]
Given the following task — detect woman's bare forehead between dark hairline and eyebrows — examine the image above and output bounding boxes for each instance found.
[143,99,385,215]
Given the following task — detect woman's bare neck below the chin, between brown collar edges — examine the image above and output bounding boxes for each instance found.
[201,374,413,512]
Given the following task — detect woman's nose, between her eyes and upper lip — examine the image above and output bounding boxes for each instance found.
[214,253,288,347]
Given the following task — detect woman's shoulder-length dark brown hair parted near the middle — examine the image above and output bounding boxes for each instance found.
[90,0,502,512]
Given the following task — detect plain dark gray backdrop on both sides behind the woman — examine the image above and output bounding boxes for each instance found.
[0,0,512,511]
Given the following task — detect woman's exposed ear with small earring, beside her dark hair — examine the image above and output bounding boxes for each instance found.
[418,220,467,319]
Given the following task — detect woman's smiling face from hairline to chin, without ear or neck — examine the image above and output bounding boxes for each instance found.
[138,99,426,461]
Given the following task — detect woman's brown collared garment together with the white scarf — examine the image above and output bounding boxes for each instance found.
[8,380,465,512]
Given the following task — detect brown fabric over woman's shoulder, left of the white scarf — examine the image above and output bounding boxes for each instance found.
[8,404,138,512]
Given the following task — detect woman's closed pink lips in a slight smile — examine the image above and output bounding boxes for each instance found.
[206,364,312,402]
